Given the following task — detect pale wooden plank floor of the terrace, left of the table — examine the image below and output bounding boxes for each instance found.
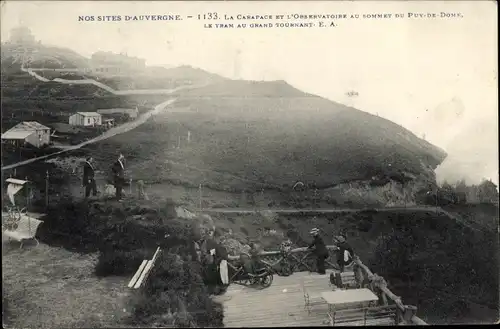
[215,270,332,327]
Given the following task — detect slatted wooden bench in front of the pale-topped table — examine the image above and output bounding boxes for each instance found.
[328,305,399,326]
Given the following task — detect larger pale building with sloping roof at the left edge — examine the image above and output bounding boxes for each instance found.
[2,121,50,147]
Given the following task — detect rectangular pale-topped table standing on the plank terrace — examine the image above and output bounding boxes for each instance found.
[321,288,378,325]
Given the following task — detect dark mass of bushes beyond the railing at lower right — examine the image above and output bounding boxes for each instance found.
[371,214,499,317]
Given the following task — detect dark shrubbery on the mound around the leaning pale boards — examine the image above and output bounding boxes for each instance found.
[38,200,223,327]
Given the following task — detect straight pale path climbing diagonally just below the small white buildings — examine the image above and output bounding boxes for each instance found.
[2,99,175,170]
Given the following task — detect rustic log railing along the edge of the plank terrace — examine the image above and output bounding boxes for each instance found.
[229,245,427,325]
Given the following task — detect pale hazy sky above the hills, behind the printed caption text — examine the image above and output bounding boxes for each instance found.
[1,1,498,184]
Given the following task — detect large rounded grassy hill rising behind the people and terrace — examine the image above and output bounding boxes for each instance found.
[89,80,446,190]
